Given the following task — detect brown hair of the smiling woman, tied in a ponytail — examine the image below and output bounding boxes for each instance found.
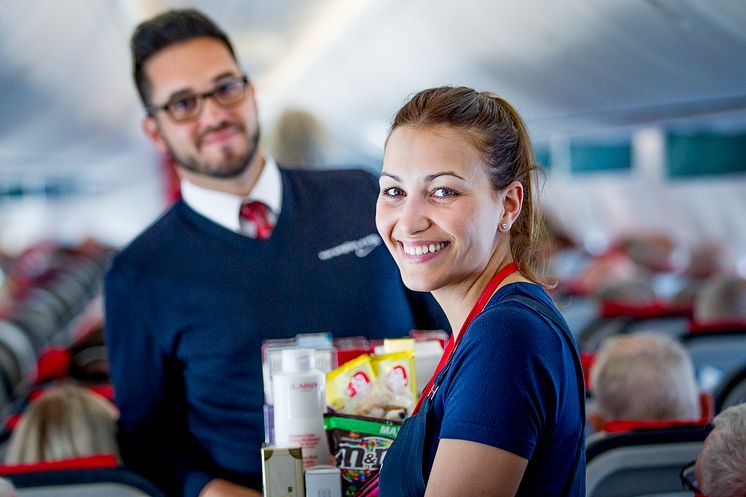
[389,86,547,283]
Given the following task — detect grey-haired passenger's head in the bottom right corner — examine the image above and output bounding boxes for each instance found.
[696,404,746,497]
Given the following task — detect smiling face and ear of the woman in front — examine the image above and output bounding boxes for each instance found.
[377,126,506,296]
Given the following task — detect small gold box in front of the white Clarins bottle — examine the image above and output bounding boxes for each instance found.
[262,446,306,497]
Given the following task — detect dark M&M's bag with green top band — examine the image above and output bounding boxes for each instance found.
[324,414,401,497]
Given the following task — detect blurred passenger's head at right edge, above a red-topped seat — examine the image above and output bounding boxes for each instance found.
[694,275,746,323]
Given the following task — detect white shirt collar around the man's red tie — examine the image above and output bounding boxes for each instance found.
[181,155,282,232]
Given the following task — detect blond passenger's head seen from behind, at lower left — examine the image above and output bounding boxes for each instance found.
[5,385,119,464]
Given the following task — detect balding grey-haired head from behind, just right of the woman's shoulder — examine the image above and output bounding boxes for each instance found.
[590,333,701,430]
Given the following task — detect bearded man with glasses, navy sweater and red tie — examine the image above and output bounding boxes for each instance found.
[106,10,444,497]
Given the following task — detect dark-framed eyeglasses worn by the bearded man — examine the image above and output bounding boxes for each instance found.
[147,76,249,122]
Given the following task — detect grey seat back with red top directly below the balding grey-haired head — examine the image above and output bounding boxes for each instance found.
[586,421,711,497]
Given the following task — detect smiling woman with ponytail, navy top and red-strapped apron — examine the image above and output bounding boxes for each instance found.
[376,87,585,497]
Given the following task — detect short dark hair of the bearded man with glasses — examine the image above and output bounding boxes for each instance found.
[130,9,237,106]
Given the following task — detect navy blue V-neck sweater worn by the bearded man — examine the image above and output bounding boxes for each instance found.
[105,170,446,496]
